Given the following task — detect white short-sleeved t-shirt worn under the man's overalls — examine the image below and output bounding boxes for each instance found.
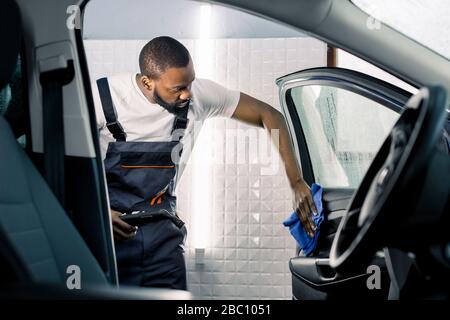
[92,73,240,190]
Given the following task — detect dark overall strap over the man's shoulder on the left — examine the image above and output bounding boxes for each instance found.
[97,77,127,141]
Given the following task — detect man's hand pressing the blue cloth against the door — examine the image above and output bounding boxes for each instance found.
[292,179,317,237]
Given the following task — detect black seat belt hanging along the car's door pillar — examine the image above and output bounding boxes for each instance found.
[40,60,75,207]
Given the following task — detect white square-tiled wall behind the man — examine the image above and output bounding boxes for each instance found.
[85,38,326,299]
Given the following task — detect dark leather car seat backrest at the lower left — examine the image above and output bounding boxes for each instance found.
[0,117,107,284]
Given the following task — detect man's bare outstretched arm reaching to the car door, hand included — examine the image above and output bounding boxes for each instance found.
[232,93,317,236]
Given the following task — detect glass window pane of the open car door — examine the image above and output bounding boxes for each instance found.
[288,85,399,188]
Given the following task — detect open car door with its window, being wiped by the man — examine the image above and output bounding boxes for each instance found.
[277,68,411,299]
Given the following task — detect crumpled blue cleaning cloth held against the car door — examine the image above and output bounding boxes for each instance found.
[283,183,324,256]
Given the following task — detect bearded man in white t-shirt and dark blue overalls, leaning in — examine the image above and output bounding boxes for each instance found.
[93,37,315,289]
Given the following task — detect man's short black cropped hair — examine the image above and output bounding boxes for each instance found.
[139,37,191,79]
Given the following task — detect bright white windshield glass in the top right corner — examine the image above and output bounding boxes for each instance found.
[352,0,450,60]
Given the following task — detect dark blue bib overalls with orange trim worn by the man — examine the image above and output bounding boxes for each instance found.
[97,78,189,290]
